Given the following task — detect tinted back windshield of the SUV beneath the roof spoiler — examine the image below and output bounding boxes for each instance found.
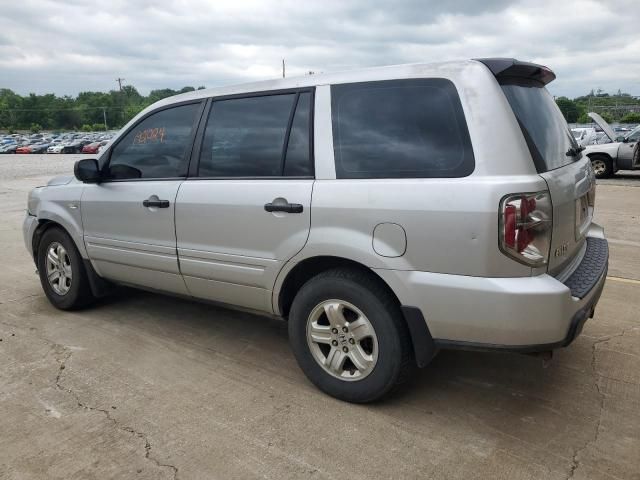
[502,82,581,173]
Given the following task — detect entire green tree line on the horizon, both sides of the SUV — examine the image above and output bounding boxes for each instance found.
[0,85,640,131]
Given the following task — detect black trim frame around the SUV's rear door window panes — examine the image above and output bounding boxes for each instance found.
[187,87,316,180]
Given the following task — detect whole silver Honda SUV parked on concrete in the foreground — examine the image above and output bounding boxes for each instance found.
[24,59,608,402]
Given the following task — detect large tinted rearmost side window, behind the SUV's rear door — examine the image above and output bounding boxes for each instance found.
[331,78,475,178]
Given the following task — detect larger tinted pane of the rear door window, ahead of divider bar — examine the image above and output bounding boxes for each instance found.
[198,94,296,177]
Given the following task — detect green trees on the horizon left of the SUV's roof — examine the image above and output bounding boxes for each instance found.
[0,85,205,131]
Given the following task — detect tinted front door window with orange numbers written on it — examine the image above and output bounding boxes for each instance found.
[106,103,200,179]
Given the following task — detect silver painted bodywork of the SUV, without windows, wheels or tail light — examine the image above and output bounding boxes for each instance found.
[24,61,606,345]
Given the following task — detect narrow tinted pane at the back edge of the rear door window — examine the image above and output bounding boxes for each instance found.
[284,93,313,177]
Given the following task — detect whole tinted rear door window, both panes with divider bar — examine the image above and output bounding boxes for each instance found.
[198,92,312,177]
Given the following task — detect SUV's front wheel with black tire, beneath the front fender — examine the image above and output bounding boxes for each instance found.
[37,227,94,310]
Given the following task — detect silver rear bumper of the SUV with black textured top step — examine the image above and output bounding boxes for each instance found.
[377,231,608,352]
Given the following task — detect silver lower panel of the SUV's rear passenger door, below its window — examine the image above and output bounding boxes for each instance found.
[176,179,313,312]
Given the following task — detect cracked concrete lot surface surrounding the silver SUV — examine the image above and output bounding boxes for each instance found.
[0,156,640,480]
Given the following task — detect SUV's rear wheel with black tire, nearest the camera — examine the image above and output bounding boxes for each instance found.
[289,269,414,403]
